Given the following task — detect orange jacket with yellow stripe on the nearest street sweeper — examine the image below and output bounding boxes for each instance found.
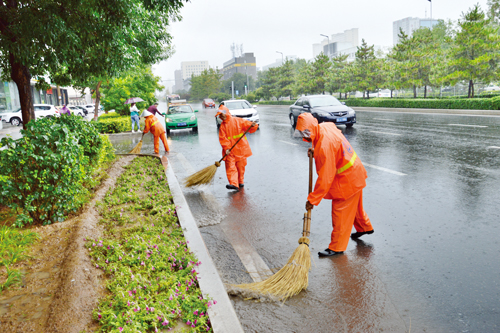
[297,116,367,205]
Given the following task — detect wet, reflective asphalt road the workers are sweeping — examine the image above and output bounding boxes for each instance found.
[111,105,500,332]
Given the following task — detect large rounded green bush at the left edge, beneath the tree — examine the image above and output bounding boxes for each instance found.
[0,115,114,226]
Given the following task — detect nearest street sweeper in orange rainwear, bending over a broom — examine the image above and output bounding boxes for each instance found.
[294,113,373,257]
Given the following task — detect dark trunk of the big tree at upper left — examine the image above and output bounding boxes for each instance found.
[9,54,35,129]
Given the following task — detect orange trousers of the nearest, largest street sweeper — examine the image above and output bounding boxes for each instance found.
[328,190,373,252]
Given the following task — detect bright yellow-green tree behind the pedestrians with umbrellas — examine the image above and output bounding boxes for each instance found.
[102,66,163,115]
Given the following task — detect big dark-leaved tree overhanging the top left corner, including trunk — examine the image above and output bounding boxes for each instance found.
[0,0,186,127]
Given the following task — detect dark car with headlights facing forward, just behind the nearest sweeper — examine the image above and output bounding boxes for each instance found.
[288,95,356,128]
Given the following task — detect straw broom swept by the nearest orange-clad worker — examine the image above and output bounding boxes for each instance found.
[230,152,313,301]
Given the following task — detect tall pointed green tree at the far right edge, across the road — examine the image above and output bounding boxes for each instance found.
[447,4,500,98]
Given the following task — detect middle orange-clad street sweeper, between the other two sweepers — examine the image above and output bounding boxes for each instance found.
[215,104,259,190]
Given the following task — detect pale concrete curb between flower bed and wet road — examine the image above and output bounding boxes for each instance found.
[159,155,244,333]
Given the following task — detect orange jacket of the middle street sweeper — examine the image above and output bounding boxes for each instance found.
[219,113,258,160]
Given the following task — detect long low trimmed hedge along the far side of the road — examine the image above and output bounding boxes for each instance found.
[346,97,500,110]
